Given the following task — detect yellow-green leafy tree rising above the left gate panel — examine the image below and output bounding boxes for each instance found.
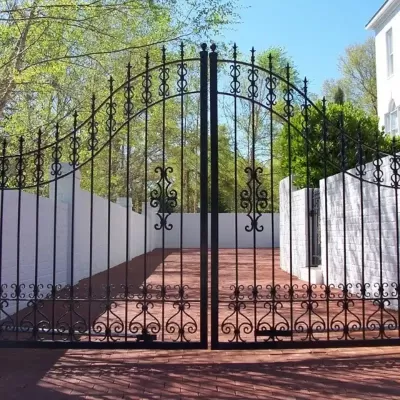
[0,0,236,140]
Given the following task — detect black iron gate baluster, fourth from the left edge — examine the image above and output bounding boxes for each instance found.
[51,123,62,341]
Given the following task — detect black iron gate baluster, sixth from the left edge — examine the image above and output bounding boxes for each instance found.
[88,94,98,342]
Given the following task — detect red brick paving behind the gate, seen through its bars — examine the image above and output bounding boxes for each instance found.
[1,249,392,342]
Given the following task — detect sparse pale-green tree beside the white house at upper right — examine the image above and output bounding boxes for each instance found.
[323,38,378,114]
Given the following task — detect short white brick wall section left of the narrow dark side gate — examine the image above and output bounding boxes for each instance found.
[279,177,312,277]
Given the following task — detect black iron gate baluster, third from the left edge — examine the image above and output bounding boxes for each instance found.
[33,129,43,340]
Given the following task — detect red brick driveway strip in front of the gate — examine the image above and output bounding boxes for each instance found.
[0,347,400,400]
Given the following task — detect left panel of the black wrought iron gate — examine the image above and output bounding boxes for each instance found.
[0,45,208,349]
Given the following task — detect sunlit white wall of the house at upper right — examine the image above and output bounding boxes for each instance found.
[372,0,400,126]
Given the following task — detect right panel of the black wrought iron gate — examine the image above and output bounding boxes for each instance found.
[210,46,400,349]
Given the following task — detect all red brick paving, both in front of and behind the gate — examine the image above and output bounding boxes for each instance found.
[0,250,400,400]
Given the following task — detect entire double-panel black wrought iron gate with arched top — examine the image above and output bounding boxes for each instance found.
[0,44,400,349]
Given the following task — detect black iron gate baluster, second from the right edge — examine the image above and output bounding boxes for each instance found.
[373,131,385,339]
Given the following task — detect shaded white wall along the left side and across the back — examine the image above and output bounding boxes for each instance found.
[0,164,279,319]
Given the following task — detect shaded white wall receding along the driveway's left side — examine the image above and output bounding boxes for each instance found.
[0,164,158,319]
